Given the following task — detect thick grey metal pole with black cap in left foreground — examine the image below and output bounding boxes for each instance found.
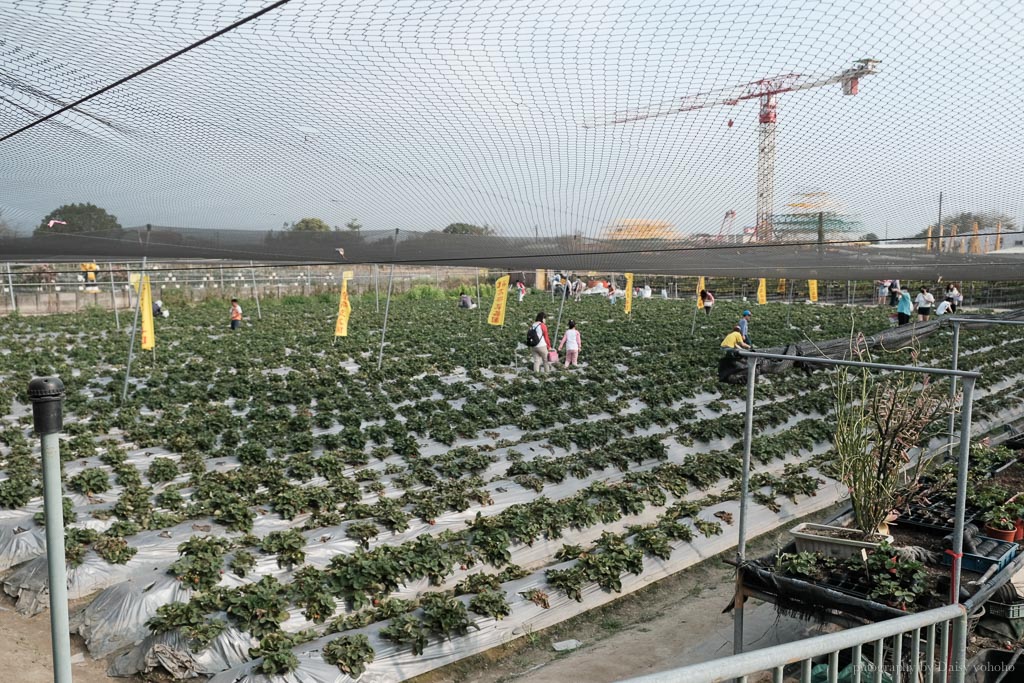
[29,377,71,683]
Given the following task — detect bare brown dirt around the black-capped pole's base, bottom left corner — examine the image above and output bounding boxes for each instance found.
[0,596,117,683]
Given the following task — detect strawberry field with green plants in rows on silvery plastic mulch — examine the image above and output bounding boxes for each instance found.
[0,290,1024,682]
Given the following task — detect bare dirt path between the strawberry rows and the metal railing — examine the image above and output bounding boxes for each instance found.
[414,509,834,683]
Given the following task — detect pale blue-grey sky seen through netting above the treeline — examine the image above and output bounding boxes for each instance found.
[0,0,1024,237]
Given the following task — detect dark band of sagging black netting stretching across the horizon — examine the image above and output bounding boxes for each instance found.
[0,226,1024,281]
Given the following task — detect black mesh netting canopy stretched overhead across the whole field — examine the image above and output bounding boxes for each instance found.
[0,0,1024,280]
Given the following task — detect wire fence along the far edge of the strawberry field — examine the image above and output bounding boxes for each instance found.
[0,261,1024,315]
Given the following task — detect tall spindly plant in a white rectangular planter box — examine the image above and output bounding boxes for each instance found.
[793,345,950,558]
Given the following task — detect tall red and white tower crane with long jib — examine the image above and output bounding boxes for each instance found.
[584,59,879,242]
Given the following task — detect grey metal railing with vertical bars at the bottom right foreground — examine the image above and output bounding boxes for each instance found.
[628,604,968,683]
